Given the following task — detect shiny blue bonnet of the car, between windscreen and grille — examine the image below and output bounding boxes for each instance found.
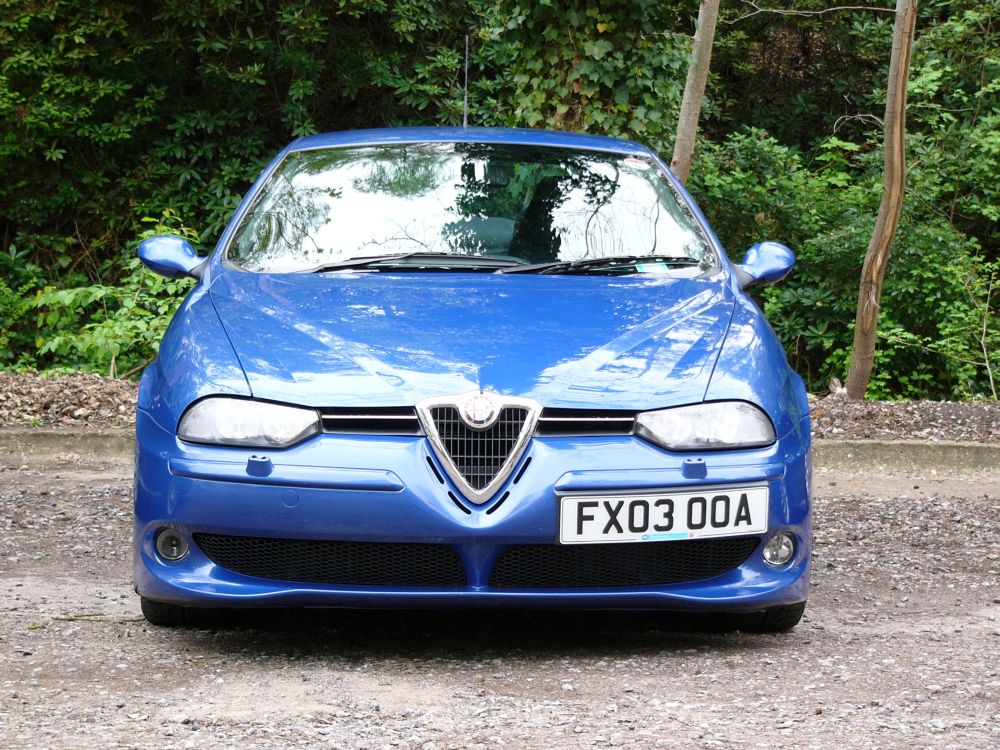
[211,270,733,409]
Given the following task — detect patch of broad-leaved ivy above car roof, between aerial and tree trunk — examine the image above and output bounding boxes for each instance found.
[487,0,691,147]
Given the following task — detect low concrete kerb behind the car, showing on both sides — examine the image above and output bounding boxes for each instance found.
[0,427,1000,474]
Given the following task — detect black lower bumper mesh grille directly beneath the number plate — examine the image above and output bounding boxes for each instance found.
[490,537,760,589]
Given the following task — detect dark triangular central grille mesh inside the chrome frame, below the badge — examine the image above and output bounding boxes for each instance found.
[431,406,528,491]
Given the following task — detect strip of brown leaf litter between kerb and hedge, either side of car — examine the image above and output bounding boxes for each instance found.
[0,372,1000,443]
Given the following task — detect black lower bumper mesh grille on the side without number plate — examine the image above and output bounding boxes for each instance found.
[194,534,466,588]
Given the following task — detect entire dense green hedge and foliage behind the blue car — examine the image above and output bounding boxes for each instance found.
[0,0,1000,398]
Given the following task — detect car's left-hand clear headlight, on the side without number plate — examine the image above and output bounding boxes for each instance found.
[177,397,320,448]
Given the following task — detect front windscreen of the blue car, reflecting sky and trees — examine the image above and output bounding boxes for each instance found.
[226,143,717,275]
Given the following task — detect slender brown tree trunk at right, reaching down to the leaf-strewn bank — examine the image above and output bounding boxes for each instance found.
[846,0,917,399]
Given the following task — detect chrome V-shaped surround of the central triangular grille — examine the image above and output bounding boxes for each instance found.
[416,391,542,505]
